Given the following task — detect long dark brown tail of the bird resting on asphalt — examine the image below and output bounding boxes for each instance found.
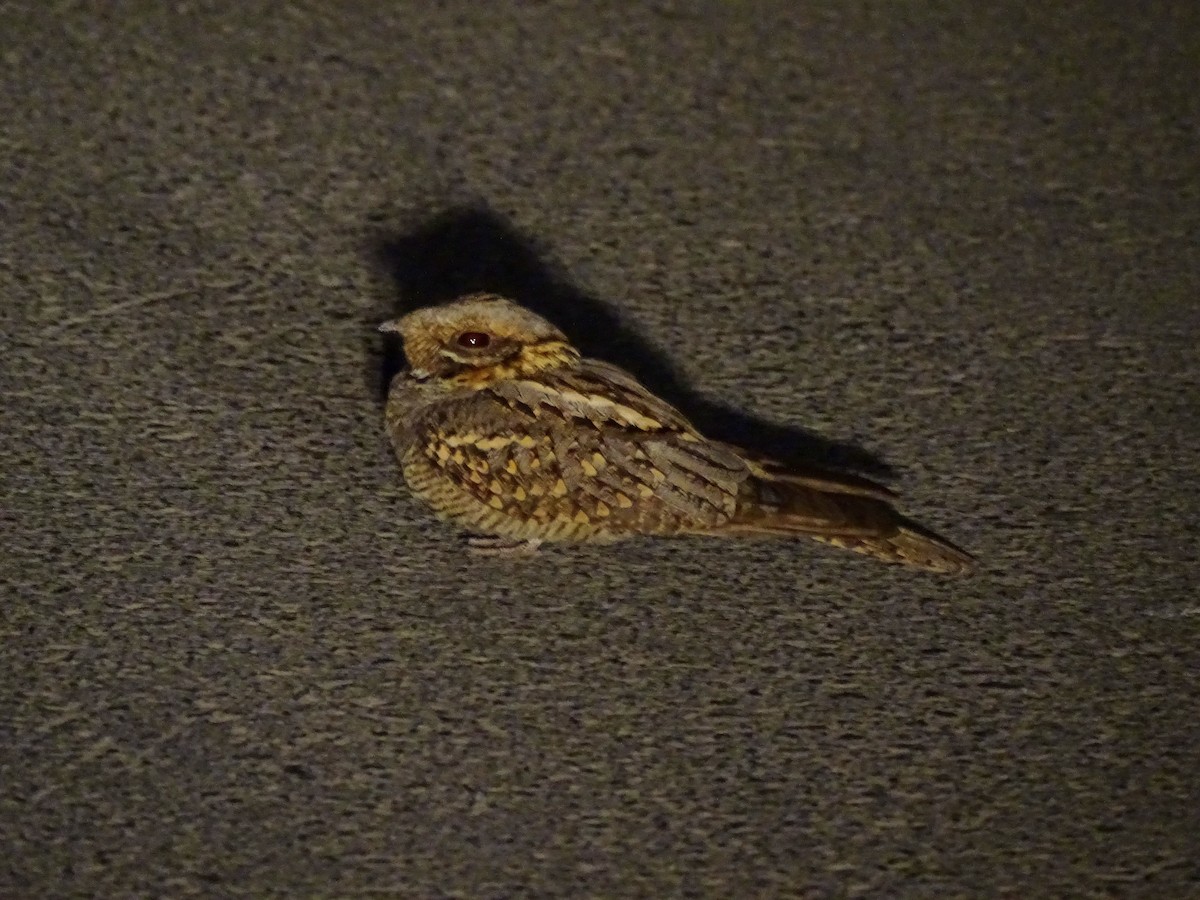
[721,452,974,575]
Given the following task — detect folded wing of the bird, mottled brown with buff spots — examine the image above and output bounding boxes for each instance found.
[418,361,749,534]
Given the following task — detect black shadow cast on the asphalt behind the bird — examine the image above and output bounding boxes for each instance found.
[367,204,894,479]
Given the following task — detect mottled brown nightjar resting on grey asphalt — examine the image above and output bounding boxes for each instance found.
[379,293,973,575]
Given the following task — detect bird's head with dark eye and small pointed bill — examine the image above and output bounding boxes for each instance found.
[379,294,580,384]
